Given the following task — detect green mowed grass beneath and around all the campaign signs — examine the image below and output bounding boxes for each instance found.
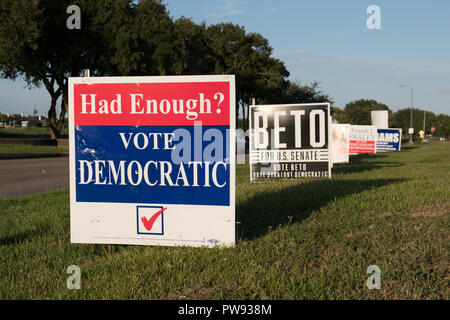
[0,142,450,299]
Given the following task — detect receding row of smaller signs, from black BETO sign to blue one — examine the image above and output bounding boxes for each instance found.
[250,103,402,181]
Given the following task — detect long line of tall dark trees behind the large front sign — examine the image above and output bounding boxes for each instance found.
[0,0,332,137]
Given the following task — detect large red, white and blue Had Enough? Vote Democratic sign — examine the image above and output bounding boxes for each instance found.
[69,75,235,246]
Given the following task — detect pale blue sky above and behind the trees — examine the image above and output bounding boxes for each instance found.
[0,0,450,114]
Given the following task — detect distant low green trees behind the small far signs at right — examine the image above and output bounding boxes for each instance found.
[332,99,450,137]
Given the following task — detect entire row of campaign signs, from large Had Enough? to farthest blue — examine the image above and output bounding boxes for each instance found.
[69,75,401,246]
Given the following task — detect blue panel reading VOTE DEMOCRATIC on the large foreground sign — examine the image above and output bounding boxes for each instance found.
[75,126,230,206]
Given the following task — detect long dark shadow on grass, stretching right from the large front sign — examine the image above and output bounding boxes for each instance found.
[236,179,406,240]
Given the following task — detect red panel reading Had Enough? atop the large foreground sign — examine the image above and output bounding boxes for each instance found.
[73,82,230,126]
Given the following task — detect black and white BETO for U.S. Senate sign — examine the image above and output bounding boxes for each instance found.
[250,103,331,181]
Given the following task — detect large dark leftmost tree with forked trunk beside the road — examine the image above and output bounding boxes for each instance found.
[0,0,86,137]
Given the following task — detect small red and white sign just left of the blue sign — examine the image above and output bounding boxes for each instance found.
[349,125,378,154]
